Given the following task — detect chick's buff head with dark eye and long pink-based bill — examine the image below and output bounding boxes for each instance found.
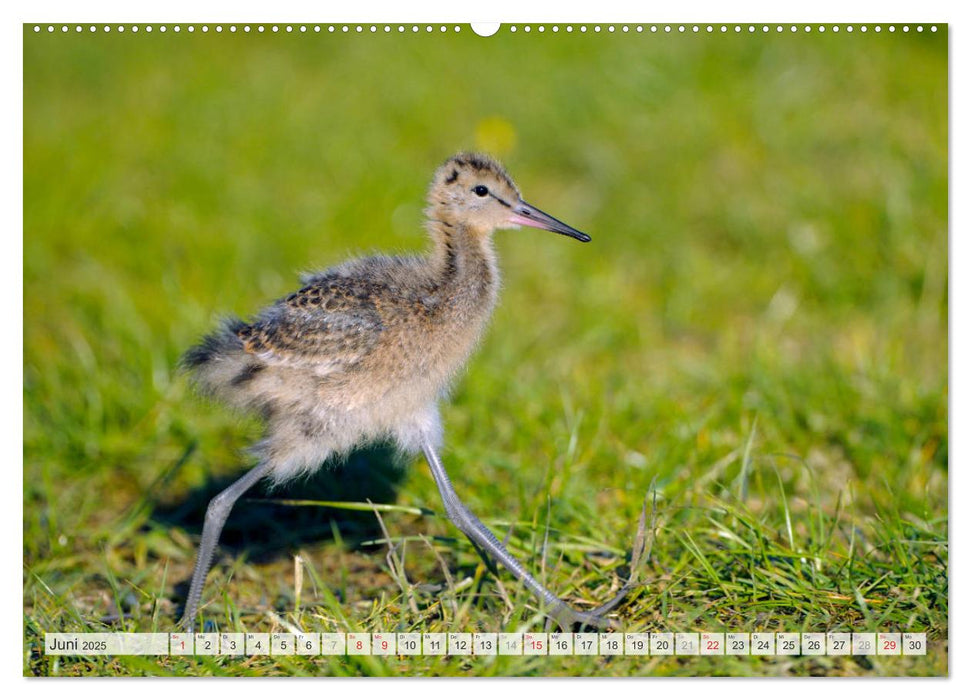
[426,153,590,243]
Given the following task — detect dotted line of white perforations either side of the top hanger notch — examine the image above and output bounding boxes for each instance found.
[34,24,937,34]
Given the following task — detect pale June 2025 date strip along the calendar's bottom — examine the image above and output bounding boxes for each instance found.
[44,632,927,657]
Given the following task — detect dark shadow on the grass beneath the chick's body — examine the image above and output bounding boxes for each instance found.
[151,445,405,568]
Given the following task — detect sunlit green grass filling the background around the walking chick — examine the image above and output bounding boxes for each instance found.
[23,27,949,676]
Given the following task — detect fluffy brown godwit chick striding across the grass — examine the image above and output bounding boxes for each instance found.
[183,153,626,630]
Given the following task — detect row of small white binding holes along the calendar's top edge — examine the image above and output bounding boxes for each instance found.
[33,24,937,34]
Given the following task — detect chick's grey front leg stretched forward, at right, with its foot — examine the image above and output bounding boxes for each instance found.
[422,440,627,631]
